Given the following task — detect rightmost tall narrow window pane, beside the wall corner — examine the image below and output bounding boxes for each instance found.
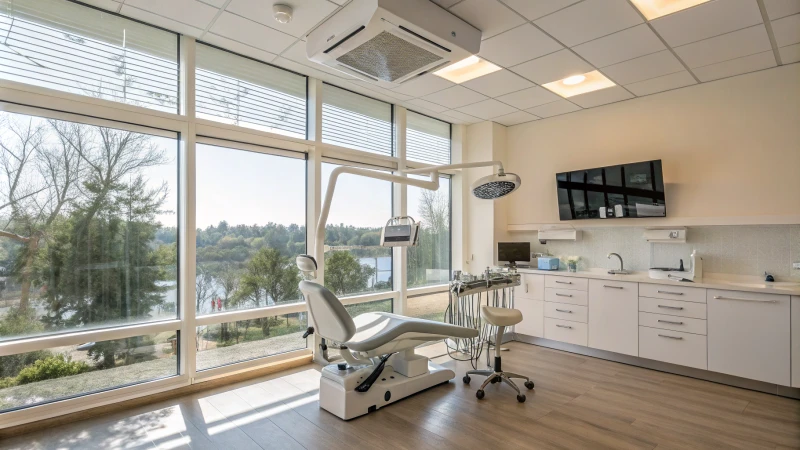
[408,177,450,288]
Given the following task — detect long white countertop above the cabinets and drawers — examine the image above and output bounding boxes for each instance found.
[517,269,800,295]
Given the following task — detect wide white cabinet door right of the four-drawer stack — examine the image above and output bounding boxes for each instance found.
[708,289,791,386]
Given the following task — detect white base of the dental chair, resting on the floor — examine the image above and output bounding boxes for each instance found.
[319,354,456,420]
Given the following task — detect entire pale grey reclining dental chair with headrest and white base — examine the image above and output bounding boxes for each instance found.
[297,255,478,420]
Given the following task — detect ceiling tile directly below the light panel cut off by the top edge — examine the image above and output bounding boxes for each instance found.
[650,0,762,47]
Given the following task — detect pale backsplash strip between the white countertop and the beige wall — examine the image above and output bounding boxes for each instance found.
[511,225,800,281]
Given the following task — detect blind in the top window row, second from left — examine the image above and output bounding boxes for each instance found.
[196,43,306,139]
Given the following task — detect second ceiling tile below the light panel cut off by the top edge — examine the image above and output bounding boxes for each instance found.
[675,25,772,68]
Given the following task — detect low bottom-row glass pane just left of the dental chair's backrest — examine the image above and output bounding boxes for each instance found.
[197,312,308,370]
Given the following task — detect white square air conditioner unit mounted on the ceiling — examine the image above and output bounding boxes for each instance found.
[306,0,481,89]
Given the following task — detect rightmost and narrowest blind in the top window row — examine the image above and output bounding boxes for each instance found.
[406,111,450,164]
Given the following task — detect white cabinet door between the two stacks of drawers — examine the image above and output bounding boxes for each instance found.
[589,280,639,356]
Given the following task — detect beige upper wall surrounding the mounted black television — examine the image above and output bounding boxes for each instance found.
[506,64,800,226]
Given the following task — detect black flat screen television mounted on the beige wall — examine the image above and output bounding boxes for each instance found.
[556,159,667,220]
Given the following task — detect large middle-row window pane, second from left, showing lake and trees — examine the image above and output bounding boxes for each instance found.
[195,144,306,315]
